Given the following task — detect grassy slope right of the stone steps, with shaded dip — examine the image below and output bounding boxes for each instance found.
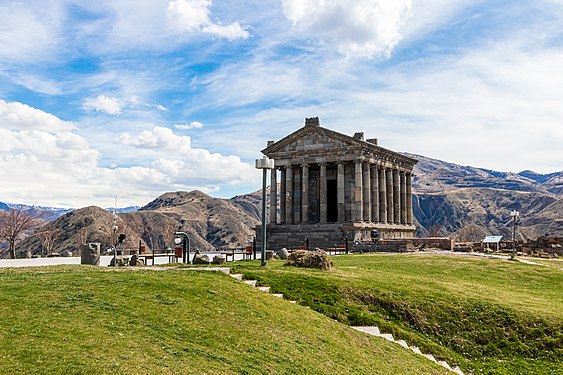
[232,254,563,374]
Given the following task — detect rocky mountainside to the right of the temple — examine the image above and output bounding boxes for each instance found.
[409,155,563,240]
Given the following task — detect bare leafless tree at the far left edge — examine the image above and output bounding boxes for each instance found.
[0,206,41,259]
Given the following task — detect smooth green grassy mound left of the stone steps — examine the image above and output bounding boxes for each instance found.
[0,266,444,374]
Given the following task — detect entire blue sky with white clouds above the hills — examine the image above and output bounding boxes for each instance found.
[0,0,563,207]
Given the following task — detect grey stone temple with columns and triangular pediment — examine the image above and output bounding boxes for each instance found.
[262,117,417,250]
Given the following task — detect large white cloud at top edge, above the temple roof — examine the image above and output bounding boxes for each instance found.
[282,0,411,58]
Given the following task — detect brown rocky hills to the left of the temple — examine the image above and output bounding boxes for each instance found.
[19,191,258,254]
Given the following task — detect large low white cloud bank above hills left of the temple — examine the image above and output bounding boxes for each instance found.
[0,101,258,207]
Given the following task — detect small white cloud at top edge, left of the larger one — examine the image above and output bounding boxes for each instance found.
[167,0,249,40]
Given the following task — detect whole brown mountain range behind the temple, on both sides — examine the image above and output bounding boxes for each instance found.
[5,154,563,258]
